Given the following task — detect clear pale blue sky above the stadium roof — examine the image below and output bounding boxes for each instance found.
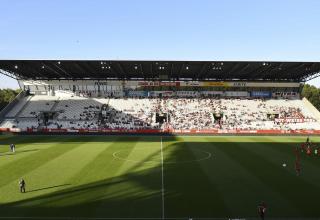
[0,0,320,88]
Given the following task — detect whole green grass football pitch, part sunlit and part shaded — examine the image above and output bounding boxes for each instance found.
[0,135,320,219]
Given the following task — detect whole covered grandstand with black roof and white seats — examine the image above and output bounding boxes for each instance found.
[0,60,320,133]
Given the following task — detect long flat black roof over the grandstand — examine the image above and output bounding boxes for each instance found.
[0,60,320,81]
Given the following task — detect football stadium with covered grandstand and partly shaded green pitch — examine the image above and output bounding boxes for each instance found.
[0,60,320,220]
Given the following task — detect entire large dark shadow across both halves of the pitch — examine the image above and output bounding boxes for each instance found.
[0,137,320,219]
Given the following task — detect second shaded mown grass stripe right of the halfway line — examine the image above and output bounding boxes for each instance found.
[203,137,299,218]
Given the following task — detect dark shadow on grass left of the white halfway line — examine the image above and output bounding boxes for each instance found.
[0,164,161,218]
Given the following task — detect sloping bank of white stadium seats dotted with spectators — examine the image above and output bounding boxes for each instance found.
[0,93,320,130]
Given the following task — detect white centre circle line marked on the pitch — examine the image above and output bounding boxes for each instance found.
[112,148,212,164]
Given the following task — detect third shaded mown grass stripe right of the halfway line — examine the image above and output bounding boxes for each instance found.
[216,137,319,217]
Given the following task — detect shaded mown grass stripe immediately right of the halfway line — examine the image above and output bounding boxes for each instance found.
[164,138,228,218]
